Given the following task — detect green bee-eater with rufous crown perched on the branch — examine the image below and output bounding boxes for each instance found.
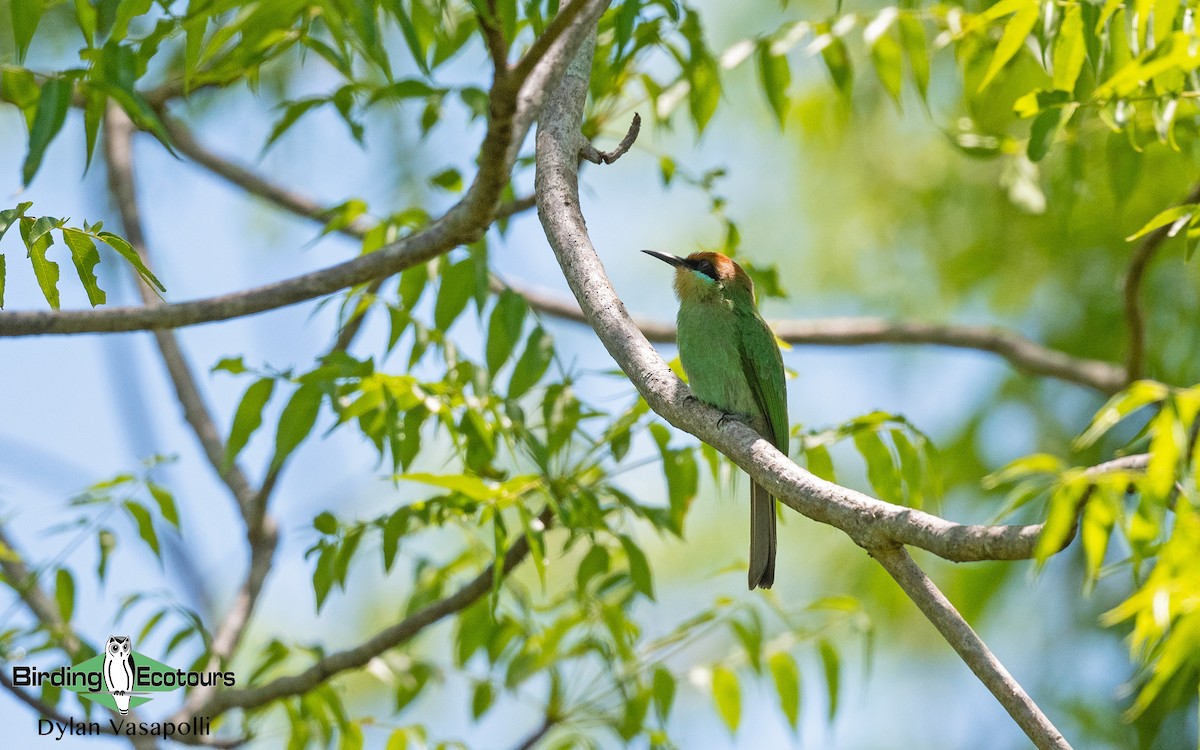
[642,250,788,590]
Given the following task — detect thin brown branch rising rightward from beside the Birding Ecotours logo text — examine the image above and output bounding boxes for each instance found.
[185,508,554,716]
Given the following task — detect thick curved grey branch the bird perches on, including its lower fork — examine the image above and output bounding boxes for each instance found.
[535,21,1084,746]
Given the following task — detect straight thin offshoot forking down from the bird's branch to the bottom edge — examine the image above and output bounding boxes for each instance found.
[868,546,1070,750]
